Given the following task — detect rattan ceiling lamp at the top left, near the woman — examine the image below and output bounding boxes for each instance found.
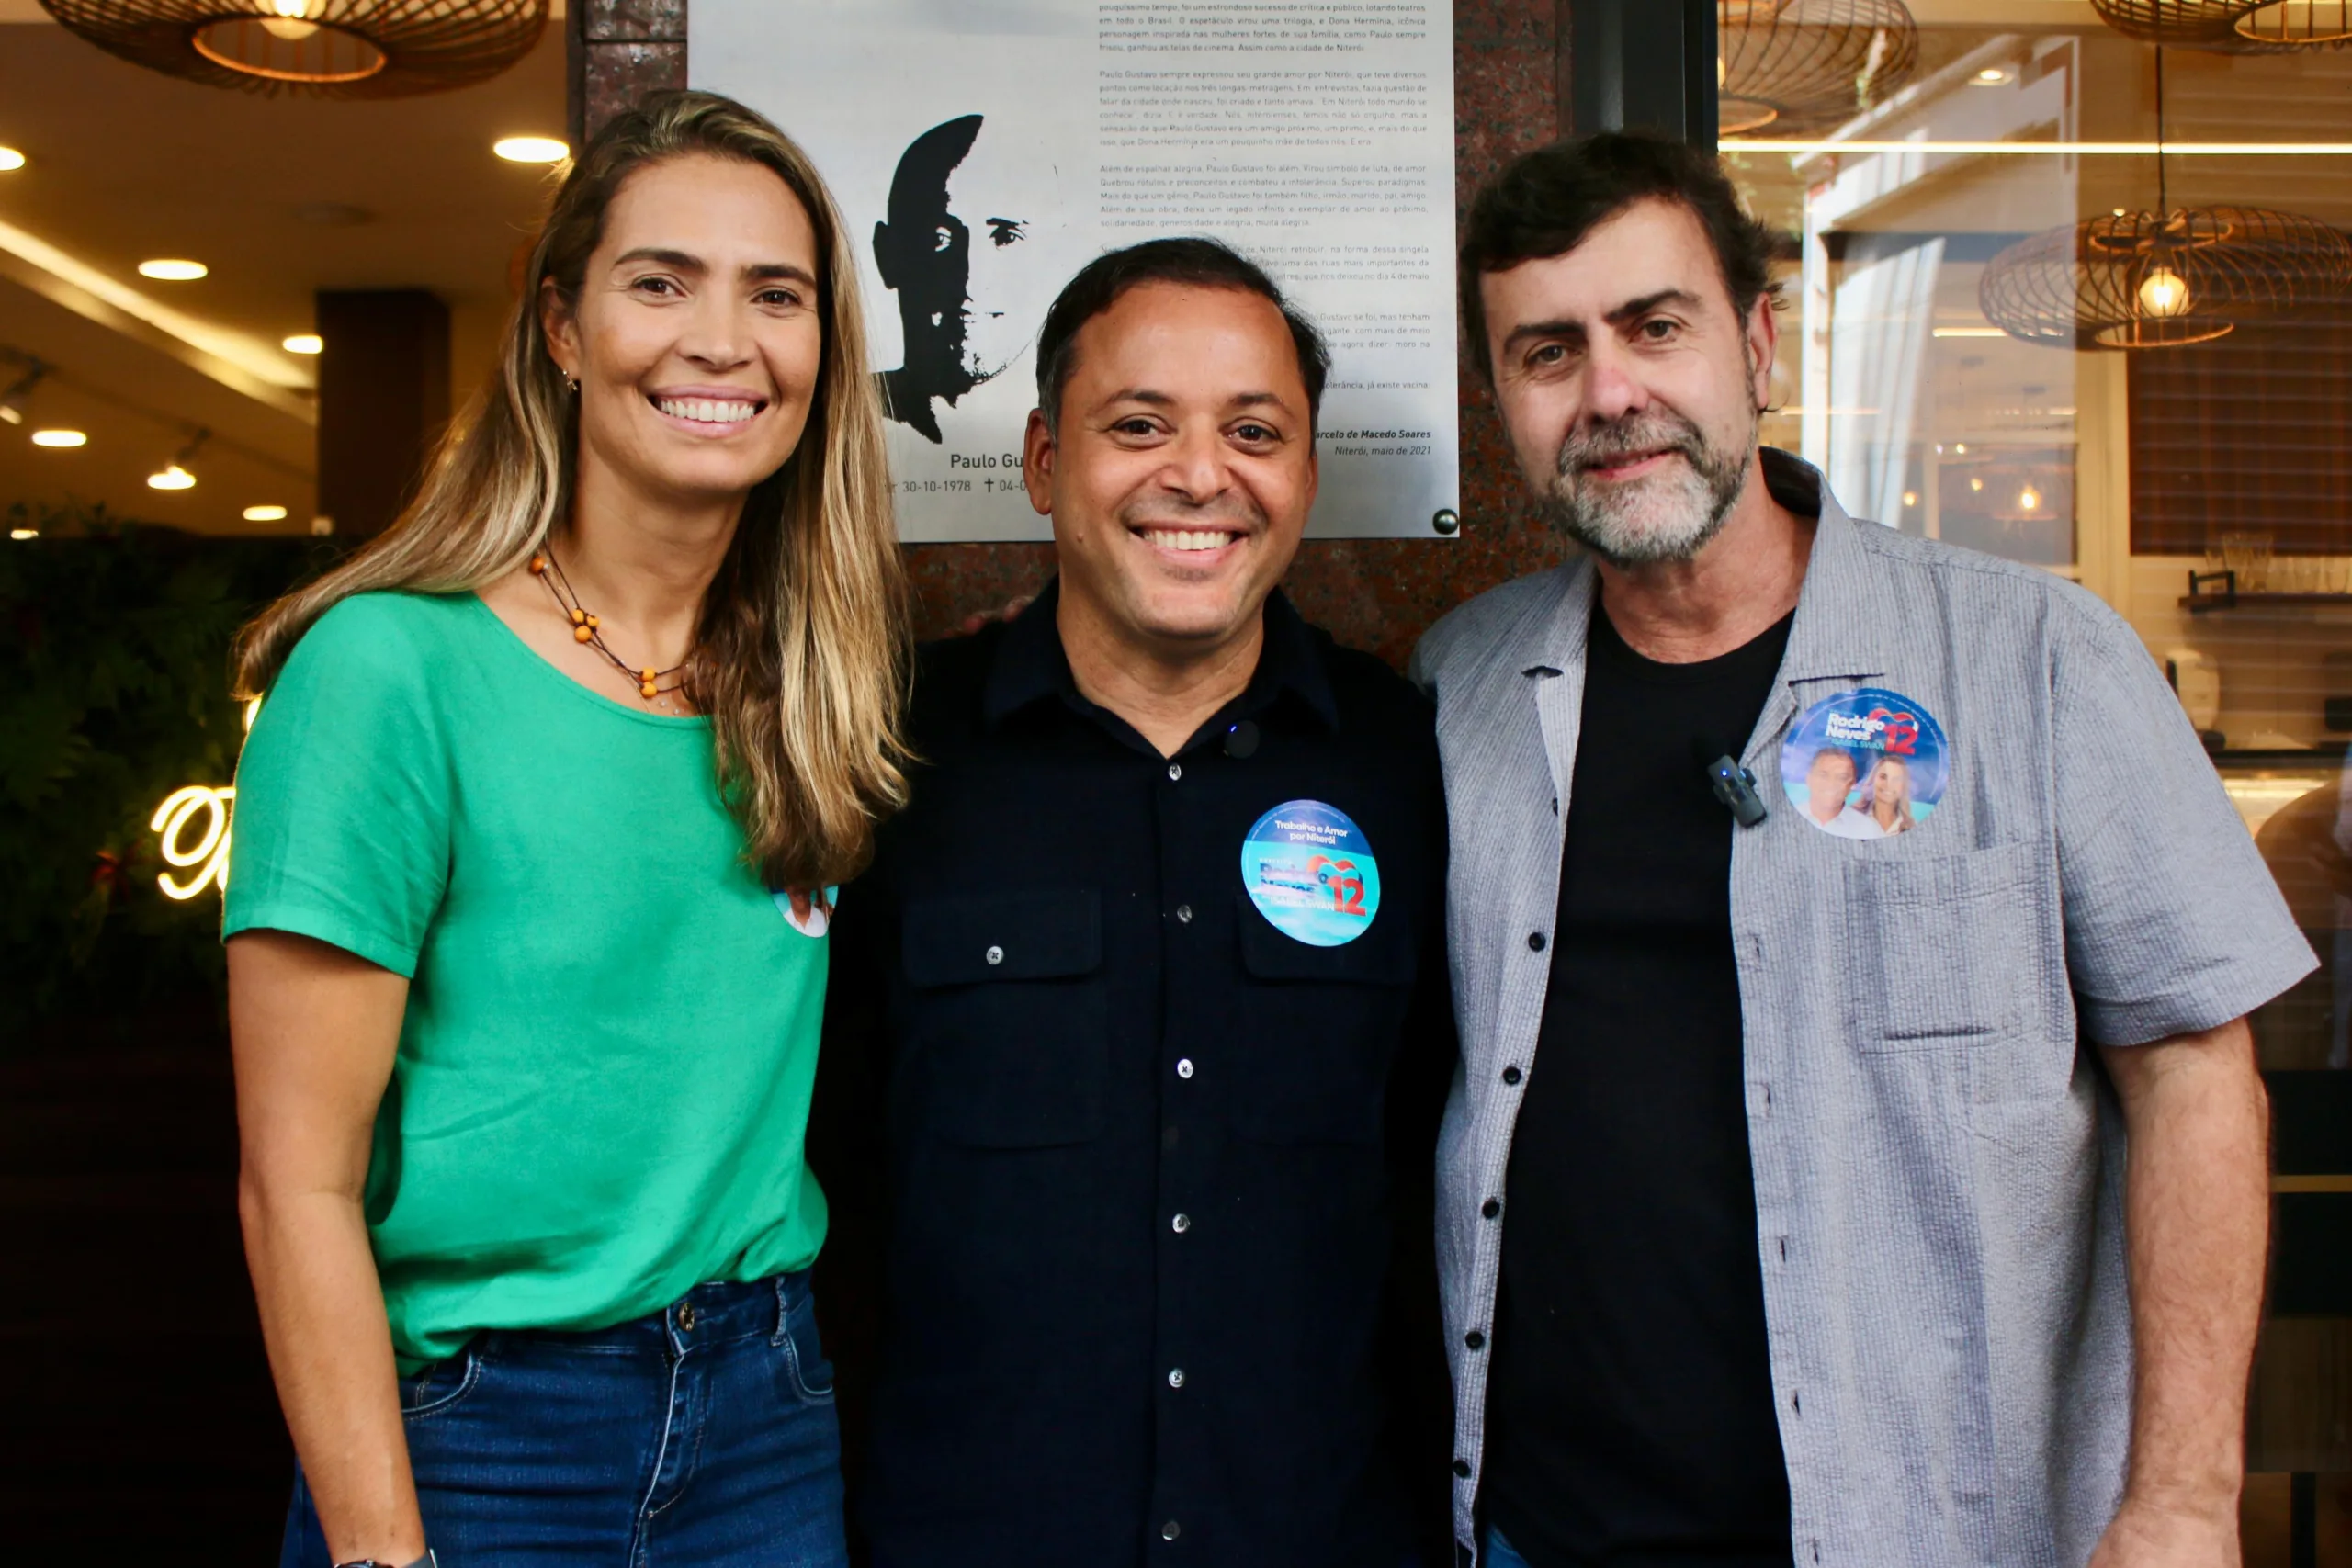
[40,0,548,98]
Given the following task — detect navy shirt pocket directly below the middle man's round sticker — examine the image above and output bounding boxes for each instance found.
[1226,894,1416,1143]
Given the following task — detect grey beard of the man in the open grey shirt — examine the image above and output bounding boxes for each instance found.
[1543,413,1755,567]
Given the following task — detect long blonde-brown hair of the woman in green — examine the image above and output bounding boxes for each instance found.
[238,92,910,888]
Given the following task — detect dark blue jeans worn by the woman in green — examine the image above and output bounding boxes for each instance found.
[277,1272,849,1568]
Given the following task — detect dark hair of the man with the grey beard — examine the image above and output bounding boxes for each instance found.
[1458,131,1773,381]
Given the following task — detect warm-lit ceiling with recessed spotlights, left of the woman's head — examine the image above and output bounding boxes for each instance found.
[0,0,564,543]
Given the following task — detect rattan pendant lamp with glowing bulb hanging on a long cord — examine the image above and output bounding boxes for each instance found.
[1975,45,2352,348]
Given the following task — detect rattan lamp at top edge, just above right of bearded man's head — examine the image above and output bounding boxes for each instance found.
[1714,0,1919,136]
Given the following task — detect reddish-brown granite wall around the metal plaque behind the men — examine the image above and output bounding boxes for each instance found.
[571,0,1566,663]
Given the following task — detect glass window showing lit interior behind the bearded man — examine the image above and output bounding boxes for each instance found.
[1724,0,2352,1493]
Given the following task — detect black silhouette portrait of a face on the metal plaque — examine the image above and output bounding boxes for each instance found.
[875,115,1035,442]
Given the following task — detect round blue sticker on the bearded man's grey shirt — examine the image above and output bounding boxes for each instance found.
[1781,686,1952,840]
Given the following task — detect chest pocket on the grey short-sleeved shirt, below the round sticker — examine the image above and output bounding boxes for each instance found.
[1844,844,2041,1054]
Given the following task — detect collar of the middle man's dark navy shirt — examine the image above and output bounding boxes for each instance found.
[981,576,1339,757]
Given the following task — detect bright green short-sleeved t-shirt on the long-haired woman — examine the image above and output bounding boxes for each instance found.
[223,592,828,1373]
